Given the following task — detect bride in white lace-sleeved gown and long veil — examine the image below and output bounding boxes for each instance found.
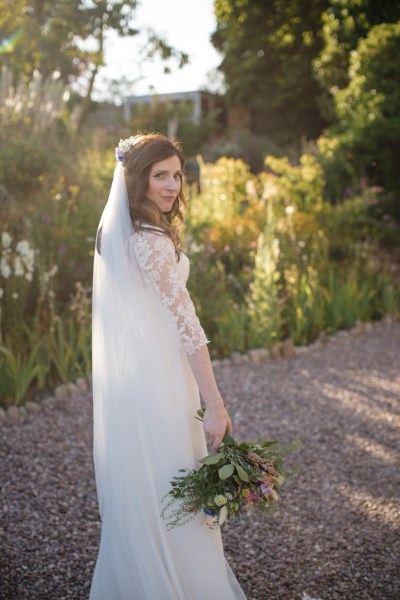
[90,134,245,600]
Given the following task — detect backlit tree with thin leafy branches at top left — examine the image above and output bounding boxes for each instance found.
[0,0,187,127]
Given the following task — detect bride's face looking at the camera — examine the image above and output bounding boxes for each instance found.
[146,156,182,213]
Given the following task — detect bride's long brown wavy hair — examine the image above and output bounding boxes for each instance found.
[124,133,187,254]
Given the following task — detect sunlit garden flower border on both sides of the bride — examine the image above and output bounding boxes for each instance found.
[0,135,400,408]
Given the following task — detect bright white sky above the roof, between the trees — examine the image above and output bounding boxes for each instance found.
[93,0,221,100]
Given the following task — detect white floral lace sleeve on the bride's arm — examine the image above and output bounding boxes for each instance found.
[134,232,208,354]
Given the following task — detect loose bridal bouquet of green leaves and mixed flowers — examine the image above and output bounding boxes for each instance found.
[161,409,299,529]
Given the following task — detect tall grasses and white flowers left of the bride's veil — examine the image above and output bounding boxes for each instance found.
[0,82,108,405]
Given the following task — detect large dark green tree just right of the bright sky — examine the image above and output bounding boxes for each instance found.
[212,0,329,144]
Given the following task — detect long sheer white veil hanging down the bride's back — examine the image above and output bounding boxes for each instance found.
[92,163,183,515]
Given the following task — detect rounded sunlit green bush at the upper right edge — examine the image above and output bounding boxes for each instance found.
[320,23,400,218]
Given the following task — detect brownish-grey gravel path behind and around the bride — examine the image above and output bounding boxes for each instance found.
[0,322,400,600]
